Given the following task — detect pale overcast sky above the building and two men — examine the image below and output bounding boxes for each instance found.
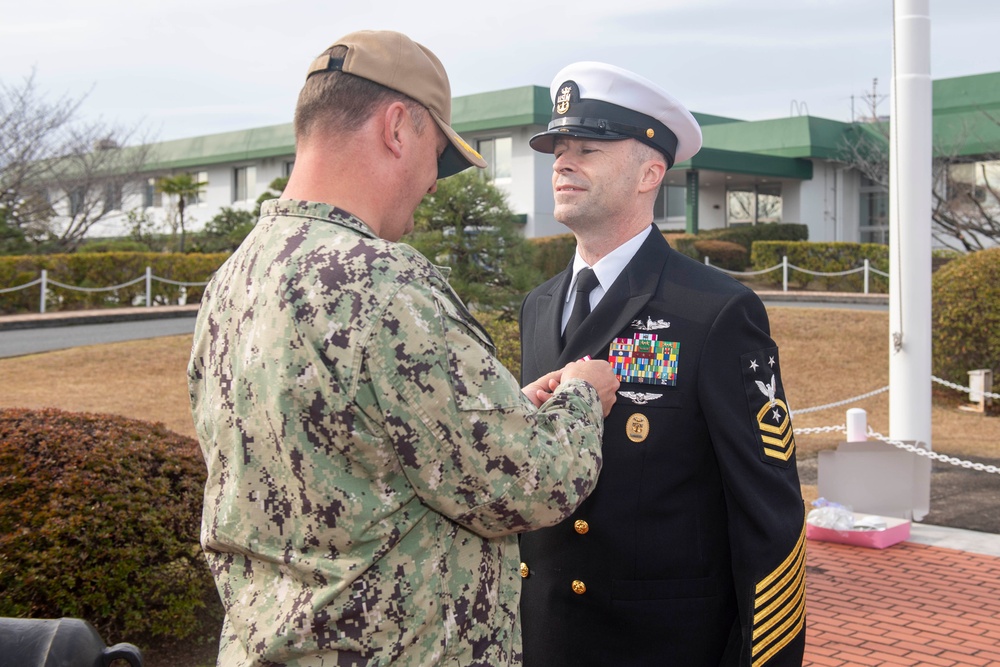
[0,0,1000,140]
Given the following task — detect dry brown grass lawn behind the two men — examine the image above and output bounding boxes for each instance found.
[0,307,1000,458]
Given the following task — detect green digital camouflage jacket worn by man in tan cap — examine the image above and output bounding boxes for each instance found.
[188,200,603,667]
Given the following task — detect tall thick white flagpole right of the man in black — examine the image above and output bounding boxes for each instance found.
[889,0,932,449]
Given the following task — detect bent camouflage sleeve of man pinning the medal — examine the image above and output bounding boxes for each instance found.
[365,283,603,537]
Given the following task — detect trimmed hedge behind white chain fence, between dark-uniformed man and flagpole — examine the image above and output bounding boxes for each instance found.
[750,241,889,293]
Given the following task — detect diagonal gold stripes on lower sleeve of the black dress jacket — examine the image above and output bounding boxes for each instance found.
[752,522,806,667]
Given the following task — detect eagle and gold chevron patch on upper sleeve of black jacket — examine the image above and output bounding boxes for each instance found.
[740,347,795,467]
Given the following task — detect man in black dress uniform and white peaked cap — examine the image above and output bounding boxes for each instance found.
[521,63,805,667]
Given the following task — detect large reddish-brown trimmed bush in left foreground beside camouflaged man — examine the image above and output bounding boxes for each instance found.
[0,409,222,644]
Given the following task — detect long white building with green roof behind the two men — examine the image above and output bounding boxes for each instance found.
[84,73,1000,248]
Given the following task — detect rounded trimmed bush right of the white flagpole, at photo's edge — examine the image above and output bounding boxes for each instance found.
[931,248,1000,391]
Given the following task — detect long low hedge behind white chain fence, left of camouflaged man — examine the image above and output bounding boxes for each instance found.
[0,252,228,314]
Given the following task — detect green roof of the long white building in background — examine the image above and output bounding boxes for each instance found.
[137,72,1000,178]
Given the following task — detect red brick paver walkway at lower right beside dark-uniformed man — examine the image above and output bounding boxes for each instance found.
[805,540,1000,667]
